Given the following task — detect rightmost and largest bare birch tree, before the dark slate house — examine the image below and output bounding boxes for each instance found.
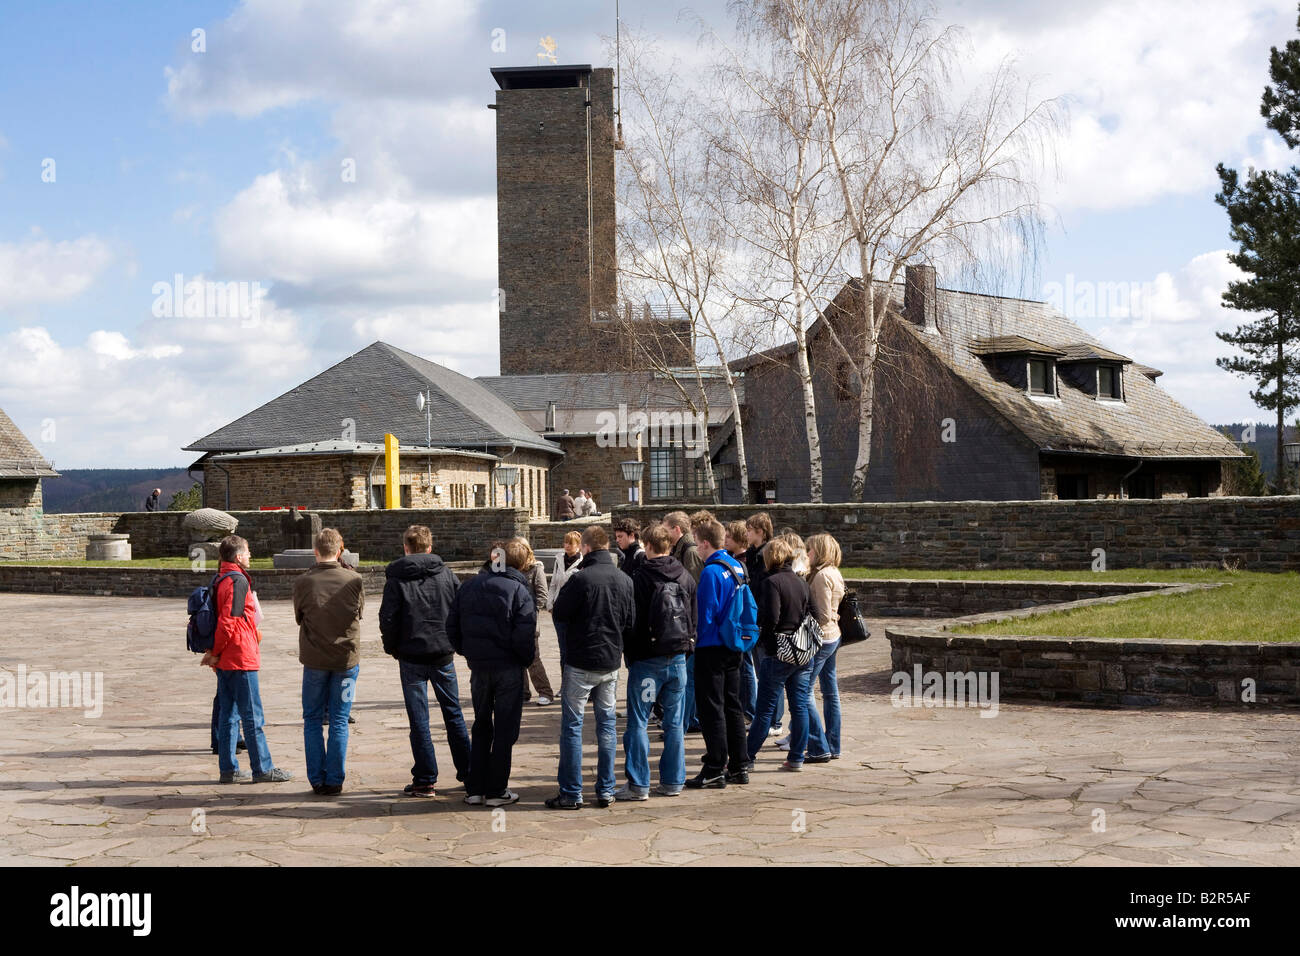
[733,0,1057,499]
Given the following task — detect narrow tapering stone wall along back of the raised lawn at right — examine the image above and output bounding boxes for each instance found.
[845,575,1167,618]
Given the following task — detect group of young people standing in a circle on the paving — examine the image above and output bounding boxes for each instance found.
[203,511,845,809]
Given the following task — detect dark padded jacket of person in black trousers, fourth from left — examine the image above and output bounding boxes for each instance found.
[447,567,537,670]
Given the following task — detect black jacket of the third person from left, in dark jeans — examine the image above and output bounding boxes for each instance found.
[380,554,460,666]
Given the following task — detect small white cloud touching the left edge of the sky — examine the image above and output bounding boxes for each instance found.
[0,235,113,308]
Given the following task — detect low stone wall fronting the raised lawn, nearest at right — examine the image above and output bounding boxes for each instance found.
[885,627,1300,708]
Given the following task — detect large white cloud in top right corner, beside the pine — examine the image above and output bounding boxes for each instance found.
[945,0,1296,209]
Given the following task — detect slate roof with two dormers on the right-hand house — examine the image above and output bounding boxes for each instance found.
[731,280,1243,458]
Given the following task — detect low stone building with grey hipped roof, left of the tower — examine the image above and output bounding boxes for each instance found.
[186,342,563,516]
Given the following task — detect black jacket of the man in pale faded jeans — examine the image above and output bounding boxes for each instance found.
[551,550,637,671]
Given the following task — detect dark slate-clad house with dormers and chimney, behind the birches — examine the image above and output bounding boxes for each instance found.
[714,267,1242,502]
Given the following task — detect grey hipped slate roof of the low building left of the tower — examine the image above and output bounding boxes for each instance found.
[186,342,560,453]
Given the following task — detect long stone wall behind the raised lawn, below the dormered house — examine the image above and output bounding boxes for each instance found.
[615,497,1300,571]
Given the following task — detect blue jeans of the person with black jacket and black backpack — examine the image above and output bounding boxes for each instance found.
[623,654,686,793]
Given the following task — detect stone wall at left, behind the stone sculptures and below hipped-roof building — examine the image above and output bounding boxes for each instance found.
[0,509,528,561]
